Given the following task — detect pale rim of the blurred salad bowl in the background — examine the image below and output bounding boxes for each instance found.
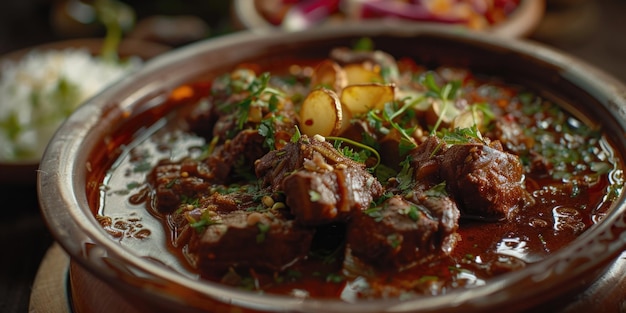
[231,0,546,37]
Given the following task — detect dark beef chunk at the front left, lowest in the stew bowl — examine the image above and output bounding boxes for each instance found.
[187,210,314,277]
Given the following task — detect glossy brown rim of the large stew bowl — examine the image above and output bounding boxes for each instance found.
[37,21,626,312]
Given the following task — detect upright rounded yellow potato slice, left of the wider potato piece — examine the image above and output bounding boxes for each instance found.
[300,88,343,137]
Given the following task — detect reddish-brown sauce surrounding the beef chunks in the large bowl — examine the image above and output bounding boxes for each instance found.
[98,51,623,300]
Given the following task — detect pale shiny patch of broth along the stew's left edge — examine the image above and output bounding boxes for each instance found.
[97,115,205,277]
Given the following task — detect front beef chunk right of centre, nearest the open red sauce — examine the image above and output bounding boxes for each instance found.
[347,196,459,269]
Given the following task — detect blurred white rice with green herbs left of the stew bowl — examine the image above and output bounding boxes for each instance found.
[0,48,142,162]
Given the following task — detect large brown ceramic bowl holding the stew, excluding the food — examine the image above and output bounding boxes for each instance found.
[38,21,626,313]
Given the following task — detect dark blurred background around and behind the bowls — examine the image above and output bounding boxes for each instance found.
[0,0,626,312]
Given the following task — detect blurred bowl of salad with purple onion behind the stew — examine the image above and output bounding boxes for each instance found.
[233,0,546,37]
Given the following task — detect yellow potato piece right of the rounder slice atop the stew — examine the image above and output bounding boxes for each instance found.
[340,83,395,115]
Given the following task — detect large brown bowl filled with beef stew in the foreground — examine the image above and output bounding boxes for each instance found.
[38,20,626,313]
